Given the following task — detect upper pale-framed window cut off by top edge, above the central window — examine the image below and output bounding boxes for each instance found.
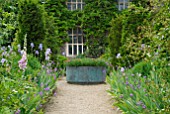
[66,0,85,11]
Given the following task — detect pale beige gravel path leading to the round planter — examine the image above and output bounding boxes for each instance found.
[45,78,120,114]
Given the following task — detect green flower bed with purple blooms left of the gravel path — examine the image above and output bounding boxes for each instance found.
[0,47,58,114]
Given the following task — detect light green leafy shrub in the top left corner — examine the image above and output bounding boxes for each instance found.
[0,0,18,46]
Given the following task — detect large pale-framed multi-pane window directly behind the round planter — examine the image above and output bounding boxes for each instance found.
[66,27,86,57]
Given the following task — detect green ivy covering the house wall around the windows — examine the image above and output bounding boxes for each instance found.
[45,0,117,57]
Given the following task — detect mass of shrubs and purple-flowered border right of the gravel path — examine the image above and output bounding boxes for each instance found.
[108,0,170,114]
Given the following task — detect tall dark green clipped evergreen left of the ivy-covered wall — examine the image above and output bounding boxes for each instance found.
[16,0,46,52]
